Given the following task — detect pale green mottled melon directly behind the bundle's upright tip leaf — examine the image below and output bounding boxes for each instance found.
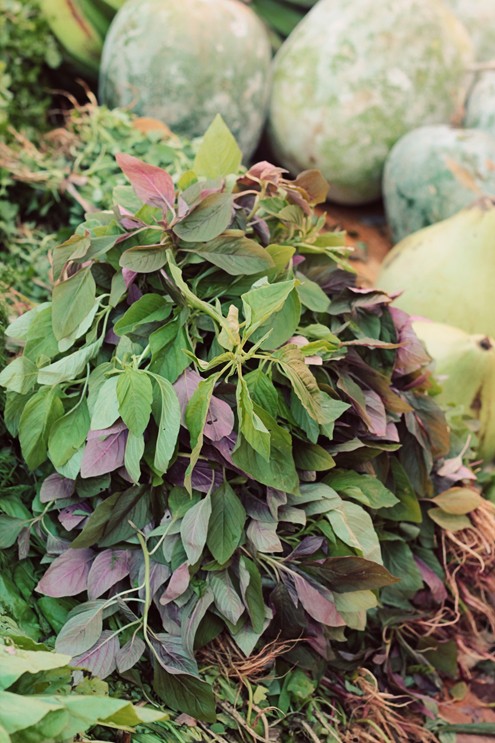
[100,0,271,158]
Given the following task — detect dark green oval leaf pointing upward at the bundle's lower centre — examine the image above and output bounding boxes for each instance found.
[206,482,246,565]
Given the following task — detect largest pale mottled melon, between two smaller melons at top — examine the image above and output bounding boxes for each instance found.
[269,0,472,204]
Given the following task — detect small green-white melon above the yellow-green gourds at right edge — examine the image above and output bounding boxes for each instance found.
[383,126,495,242]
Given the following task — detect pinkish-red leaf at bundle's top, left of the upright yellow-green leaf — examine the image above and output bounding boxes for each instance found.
[116,153,175,209]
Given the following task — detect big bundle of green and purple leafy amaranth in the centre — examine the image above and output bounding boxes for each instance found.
[0,119,472,721]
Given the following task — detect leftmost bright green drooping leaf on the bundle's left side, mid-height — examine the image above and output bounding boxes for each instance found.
[19,387,64,470]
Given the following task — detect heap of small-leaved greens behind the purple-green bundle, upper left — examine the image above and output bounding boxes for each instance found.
[0,104,194,300]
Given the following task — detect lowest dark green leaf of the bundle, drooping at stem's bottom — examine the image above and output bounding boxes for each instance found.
[153,661,216,722]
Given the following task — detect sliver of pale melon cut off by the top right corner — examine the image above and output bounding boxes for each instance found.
[446,0,495,62]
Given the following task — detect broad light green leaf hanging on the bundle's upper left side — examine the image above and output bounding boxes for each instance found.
[52,267,96,341]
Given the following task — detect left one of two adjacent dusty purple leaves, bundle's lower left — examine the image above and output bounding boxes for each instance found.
[36,549,94,598]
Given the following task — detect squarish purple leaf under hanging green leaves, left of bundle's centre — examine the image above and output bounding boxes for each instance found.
[81,422,128,477]
